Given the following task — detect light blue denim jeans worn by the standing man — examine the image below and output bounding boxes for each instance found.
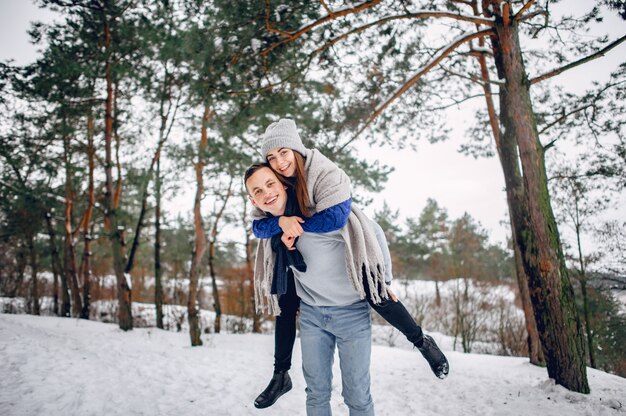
[300,301,374,416]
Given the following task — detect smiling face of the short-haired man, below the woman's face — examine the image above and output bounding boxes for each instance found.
[246,168,287,216]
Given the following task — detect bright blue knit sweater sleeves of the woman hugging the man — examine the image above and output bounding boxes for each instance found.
[252,198,352,238]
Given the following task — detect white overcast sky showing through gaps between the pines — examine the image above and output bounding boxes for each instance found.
[0,0,626,249]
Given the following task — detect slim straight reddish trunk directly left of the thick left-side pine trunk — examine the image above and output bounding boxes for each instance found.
[80,111,96,319]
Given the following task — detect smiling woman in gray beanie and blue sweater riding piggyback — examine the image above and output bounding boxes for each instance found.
[253,119,449,408]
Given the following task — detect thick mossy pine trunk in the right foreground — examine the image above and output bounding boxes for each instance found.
[484,0,589,393]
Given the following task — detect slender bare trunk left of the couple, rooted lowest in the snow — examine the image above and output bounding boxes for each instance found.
[187,103,211,346]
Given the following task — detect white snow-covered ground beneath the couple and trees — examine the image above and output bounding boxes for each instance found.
[0,314,626,416]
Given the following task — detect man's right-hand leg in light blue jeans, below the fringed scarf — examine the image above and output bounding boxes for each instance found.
[332,301,374,416]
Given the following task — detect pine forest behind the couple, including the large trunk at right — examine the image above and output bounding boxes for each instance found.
[0,0,626,400]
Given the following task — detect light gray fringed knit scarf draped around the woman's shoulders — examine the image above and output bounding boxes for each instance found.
[252,149,388,315]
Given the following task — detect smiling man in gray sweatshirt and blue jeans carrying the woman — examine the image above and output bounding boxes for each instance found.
[245,164,374,416]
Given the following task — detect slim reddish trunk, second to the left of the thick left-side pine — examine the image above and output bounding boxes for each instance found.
[63,136,82,317]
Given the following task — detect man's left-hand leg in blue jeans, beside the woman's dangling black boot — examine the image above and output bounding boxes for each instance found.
[300,302,335,416]
